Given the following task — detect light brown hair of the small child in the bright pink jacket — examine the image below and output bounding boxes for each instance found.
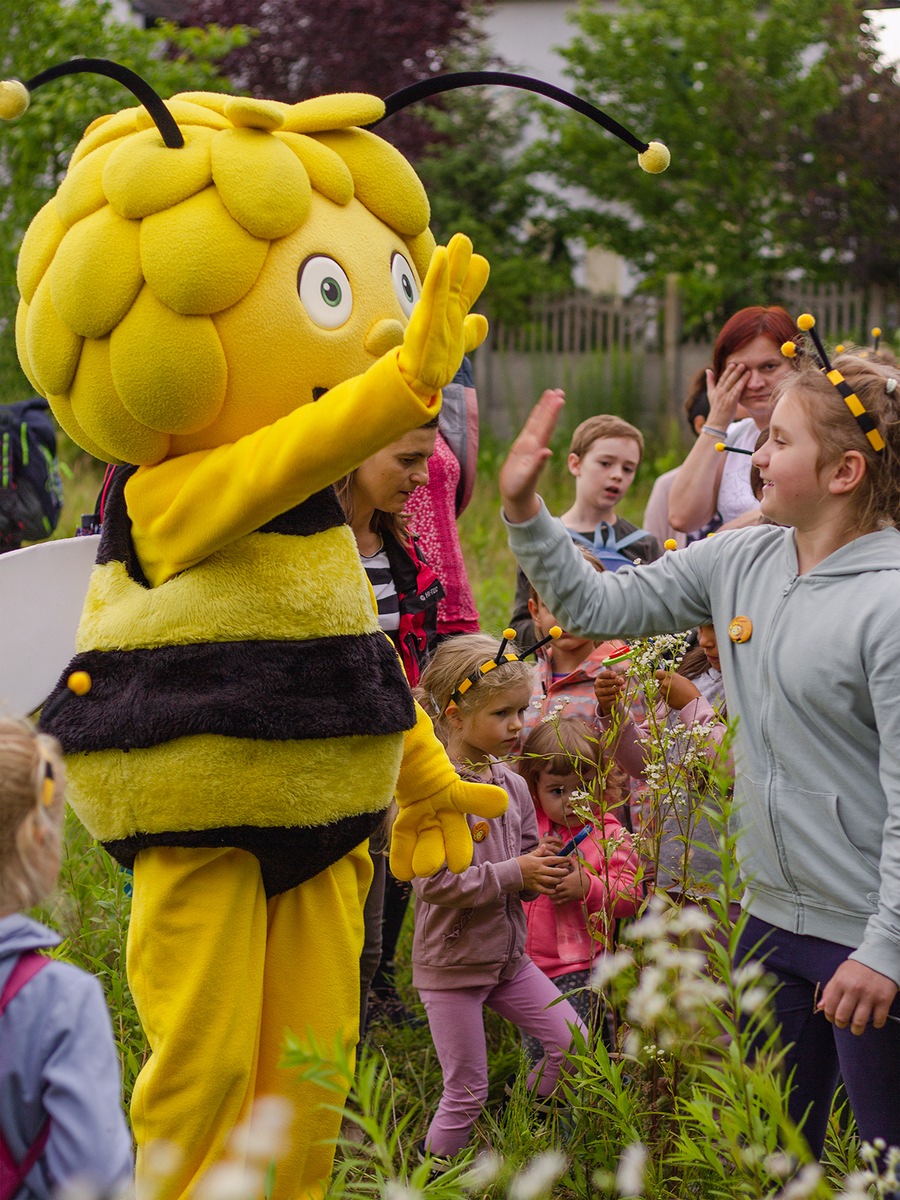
[516,716,626,810]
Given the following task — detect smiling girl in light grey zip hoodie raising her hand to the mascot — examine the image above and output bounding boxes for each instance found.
[500,355,900,1154]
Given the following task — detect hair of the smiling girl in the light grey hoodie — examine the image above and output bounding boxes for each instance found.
[776,354,900,530]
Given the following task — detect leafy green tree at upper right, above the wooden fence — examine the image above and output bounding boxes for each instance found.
[541,0,898,333]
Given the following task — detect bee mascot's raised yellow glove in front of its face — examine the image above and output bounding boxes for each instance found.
[397,233,491,400]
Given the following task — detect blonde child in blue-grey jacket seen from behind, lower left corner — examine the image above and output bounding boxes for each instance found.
[0,718,132,1200]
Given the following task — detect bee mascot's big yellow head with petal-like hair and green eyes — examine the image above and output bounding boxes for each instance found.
[16,92,434,464]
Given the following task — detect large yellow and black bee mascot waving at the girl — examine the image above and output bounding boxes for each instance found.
[0,60,672,1200]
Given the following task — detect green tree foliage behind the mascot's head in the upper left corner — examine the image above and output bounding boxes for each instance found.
[0,0,246,400]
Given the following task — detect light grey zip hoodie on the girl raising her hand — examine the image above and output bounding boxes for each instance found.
[508,504,900,985]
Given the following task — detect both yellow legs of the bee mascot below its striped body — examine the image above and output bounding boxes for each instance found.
[128,842,371,1200]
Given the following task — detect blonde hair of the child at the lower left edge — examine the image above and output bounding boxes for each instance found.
[0,716,65,912]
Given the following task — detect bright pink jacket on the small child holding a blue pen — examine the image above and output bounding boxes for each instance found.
[526,809,642,979]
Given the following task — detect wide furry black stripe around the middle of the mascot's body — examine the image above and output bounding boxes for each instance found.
[41,632,415,752]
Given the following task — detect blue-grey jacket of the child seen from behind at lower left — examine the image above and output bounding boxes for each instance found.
[0,913,133,1200]
